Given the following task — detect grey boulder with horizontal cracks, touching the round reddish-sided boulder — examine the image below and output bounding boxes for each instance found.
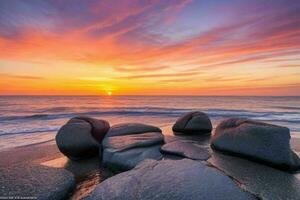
[102,123,164,171]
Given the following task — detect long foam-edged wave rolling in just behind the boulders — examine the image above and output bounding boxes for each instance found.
[0,107,300,123]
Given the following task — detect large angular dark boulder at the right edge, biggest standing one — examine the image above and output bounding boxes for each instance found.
[211,119,300,170]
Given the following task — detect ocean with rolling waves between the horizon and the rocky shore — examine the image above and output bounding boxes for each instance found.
[0,96,300,150]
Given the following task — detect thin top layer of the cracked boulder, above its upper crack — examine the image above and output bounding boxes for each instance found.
[107,123,161,137]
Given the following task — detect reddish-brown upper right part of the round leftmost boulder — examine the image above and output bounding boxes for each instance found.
[70,116,110,142]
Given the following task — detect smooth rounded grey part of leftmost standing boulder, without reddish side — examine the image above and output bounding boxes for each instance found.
[55,119,99,159]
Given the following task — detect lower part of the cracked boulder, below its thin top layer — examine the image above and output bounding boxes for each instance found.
[102,132,164,171]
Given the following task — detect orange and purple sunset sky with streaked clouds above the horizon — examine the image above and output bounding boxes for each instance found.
[0,0,300,96]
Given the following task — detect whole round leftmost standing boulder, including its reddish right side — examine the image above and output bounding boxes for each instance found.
[55,117,109,159]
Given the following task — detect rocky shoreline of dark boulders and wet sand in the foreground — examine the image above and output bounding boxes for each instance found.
[0,112,300,199]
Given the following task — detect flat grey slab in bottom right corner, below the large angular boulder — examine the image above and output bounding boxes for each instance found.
[208,152,300,200]
